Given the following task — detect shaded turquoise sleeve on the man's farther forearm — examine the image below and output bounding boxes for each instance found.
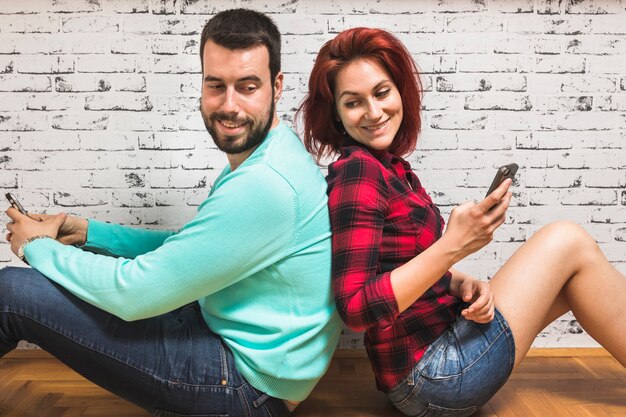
[81,219,175,259]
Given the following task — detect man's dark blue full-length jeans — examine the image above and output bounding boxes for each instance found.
[0,268,289,417]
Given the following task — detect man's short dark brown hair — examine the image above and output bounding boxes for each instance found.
[200,9,280,81]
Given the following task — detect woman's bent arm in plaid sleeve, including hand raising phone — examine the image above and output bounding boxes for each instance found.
[329,156,510,331]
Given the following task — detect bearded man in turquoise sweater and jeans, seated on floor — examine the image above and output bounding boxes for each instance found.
[0,9,341,416]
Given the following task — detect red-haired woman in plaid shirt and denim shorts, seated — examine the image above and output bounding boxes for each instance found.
[299,28,626,416]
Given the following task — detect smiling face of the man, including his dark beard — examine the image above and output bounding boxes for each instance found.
[200,40,282,157]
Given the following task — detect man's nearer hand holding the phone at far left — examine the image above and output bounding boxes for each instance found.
[6,207,67,255]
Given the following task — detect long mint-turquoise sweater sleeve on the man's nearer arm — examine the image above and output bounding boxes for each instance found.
[25,164,297,321]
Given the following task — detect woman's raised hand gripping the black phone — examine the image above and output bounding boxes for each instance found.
[441,179,511,262]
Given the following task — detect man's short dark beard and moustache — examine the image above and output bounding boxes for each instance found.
[200,87,276,154]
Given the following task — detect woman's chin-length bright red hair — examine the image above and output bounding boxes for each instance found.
[296,27,422,160]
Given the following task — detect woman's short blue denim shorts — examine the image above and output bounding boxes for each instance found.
[387,309,515,417]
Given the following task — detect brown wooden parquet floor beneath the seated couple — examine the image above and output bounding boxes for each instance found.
[0,349,626,417]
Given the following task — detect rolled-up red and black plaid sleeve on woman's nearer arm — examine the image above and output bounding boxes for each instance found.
[328,153,399,331]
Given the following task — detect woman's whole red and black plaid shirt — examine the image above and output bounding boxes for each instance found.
[327,142,461,391]
